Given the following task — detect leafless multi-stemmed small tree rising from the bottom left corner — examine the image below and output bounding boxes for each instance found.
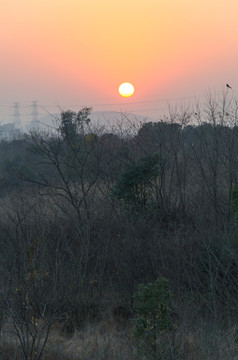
[0,193,79,360]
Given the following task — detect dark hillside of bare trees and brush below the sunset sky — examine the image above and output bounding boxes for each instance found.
[0,97,238,360]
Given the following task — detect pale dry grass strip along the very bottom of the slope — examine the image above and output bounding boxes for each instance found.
[0,319,238,360]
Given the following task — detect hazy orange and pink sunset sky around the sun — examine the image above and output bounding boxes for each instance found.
[0,0,238,122]
